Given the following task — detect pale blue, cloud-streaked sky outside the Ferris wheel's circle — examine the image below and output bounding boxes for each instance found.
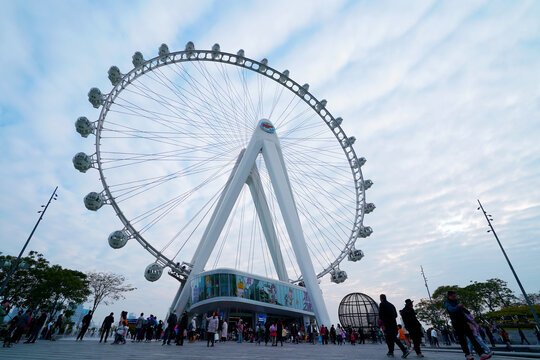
[0,0,540,322]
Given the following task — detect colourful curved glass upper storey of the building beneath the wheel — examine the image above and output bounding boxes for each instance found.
[190,272,313,312]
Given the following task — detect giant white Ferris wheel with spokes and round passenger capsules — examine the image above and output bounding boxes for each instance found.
[73,42,375,324]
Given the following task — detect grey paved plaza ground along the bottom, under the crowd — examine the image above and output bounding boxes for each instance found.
[0,340,536,360]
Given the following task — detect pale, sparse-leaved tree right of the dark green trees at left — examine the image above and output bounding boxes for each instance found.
[86,272,136,312]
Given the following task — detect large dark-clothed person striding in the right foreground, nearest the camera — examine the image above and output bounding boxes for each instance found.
[444,290,492,360]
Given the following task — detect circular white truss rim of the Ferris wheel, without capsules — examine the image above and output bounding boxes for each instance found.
[93,44,366,282]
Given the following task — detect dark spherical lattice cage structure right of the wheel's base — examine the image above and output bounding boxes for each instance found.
[338,293,379,330]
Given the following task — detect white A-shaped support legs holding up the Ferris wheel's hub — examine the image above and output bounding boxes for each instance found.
[174,119,330,325]
